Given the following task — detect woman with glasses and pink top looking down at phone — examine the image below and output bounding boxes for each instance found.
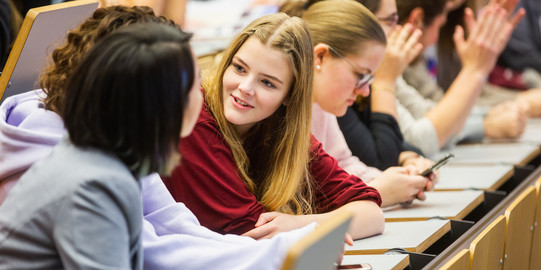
[281,1,433,209]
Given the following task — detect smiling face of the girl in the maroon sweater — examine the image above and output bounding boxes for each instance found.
[223,37,293,135]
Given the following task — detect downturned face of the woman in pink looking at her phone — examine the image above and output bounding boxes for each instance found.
[313,42,385,116]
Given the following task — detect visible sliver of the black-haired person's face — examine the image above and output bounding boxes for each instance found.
[180,54,203,137]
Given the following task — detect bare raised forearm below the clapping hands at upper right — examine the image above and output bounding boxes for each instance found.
[426,69,486,147]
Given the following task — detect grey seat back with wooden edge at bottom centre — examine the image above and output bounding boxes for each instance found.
[282,211,351,270]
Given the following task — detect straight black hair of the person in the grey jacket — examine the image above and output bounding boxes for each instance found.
[61,23,195,177]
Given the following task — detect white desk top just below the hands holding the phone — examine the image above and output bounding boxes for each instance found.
[383,190,484,222]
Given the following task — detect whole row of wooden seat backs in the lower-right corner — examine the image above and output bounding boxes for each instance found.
[442,177,541,270]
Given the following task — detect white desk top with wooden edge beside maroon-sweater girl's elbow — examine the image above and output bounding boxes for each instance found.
[345,220,451,255]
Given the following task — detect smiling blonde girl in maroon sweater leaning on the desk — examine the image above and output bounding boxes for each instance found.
[164,14,384,239]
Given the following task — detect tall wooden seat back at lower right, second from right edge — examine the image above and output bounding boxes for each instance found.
[503,186,537,269]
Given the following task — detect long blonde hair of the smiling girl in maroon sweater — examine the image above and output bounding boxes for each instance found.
[203,13,314,214]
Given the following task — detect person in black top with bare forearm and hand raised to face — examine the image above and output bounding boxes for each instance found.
[326,0,437,173]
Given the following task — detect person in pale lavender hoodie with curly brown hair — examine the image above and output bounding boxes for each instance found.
[0,7,315,269]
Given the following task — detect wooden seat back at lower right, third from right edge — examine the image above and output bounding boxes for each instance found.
[470,215,506,270]
